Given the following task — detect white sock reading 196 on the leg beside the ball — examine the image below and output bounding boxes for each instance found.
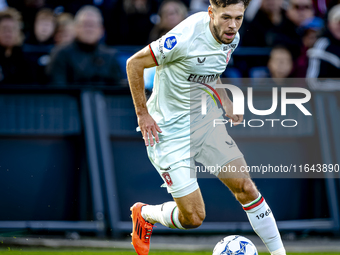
[243,194,286,255]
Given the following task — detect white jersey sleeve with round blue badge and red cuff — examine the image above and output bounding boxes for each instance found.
[149,32,187,66]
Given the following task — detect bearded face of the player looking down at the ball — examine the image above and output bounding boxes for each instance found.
[208,3,245,44]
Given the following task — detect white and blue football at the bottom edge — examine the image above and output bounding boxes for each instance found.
[213,235,258,255]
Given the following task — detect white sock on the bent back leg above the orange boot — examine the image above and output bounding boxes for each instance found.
[142,201,185,229]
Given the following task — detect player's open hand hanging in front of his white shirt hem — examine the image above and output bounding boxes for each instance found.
[138,113,162,147]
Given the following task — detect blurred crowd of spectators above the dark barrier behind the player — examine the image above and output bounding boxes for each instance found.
[0,0,340,87]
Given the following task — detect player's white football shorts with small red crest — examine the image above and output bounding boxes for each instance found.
[147,120,243,198]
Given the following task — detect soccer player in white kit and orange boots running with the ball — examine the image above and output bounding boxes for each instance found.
[127,0,286,255]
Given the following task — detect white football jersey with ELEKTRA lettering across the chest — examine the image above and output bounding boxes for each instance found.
[147,12,240,136]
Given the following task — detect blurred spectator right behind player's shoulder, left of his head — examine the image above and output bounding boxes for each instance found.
[149,0,188,42]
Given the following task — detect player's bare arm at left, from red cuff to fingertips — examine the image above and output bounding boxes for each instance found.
[126,46,162,146]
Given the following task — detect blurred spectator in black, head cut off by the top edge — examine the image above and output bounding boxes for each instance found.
[106,0,158,45]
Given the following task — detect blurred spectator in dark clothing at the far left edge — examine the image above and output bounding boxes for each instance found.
[0,8,29,84]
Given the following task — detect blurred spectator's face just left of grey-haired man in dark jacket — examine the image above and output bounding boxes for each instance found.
[54,13,75,46]
